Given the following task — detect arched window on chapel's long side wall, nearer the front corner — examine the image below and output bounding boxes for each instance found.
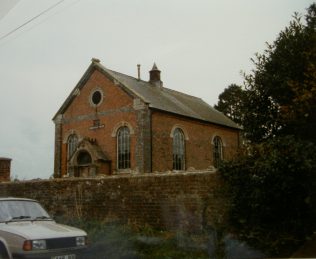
[173,128,185,170]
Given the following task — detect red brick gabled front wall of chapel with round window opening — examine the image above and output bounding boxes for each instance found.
[62,70,137,175]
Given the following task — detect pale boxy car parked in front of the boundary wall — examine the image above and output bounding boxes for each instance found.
[0,198,87,259]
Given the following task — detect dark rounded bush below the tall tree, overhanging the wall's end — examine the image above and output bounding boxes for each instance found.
[221,136,316,255]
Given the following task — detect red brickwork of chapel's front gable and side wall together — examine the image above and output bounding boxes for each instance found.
[55,70,239,176]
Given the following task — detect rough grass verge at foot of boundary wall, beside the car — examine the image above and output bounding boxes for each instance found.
[57,219,264,259]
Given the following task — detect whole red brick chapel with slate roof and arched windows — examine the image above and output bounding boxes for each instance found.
[53,59,240,178]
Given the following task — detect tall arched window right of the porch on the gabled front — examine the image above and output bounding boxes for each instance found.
[117,126,131,169]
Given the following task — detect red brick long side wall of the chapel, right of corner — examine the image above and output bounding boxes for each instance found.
[152,111,239,171]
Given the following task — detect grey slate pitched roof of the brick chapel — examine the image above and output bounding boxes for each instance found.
[54,59,239,129]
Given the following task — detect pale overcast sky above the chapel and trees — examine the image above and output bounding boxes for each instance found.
[0,0,313,180]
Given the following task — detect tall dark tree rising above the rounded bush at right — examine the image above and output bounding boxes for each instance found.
[242,4,316,143]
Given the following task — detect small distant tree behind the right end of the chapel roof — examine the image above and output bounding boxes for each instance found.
[214,84,245,125]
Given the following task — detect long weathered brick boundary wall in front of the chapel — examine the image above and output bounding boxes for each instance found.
[0,171,225,232]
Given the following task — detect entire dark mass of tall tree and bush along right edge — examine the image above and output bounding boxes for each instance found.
[220,3,316,255]
